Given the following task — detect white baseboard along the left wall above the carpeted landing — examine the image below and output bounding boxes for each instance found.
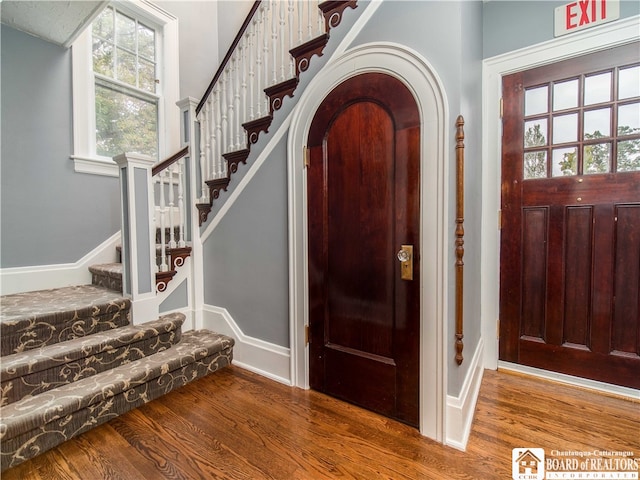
[0,232,120,295]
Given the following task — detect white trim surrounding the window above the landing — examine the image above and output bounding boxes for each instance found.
[71,0,180,177]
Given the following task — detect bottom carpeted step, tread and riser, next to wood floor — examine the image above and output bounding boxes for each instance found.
[0,330,234,471]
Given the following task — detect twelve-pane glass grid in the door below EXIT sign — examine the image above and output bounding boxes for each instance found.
[523,64,640,180]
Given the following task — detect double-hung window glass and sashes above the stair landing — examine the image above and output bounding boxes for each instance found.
[92,7,159,158]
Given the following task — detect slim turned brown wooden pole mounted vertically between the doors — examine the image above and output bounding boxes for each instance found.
[456,115,464,365]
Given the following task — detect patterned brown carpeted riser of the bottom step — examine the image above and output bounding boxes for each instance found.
[0,347,233,471]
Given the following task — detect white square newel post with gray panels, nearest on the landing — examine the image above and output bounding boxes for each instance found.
[113,153,159,325]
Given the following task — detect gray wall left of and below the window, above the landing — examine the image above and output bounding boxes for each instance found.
[0,25,120,268]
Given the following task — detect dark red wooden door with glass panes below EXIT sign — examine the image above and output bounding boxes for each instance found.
[500,43,640,388]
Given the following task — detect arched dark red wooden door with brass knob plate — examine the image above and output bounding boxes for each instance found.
[307,74,420,426]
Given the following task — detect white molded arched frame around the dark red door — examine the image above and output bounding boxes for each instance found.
[287,43,449,441]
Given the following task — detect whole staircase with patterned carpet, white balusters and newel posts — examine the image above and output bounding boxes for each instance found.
[0,0,356,471]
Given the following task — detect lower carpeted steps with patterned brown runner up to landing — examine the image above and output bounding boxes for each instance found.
[0,285,234,471]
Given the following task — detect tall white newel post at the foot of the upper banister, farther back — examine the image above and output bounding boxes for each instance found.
[177,97,204,329]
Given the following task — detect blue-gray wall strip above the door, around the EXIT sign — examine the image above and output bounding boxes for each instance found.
[483,0,640,58]
